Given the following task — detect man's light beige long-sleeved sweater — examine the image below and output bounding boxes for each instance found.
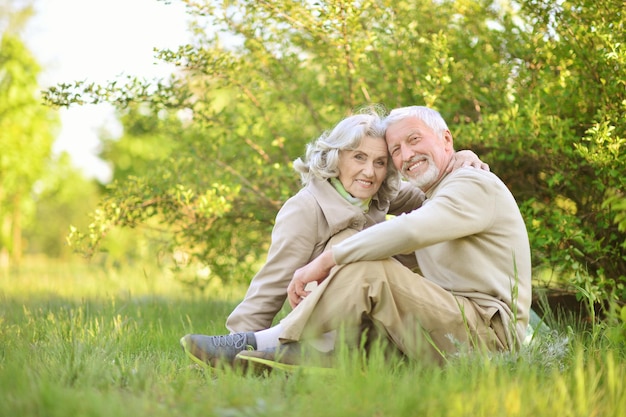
[332,168,531,342]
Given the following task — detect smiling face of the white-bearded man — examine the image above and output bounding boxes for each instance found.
[385,117,454,191]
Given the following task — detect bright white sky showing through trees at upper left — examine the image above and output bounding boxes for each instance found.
[24,0,190,183]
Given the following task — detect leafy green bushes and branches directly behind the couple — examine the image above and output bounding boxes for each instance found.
[46,0,626,297]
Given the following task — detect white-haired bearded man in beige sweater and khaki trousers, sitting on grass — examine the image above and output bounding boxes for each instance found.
[180,106,531,368]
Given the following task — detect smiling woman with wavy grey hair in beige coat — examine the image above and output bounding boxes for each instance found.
[181,112,488,365]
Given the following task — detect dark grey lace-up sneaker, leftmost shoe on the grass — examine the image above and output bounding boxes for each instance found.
[180,332,256,367]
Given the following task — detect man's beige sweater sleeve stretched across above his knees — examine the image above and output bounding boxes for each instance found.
[332,169,494,265]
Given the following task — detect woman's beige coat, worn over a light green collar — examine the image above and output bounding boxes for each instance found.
[226,179,425,332]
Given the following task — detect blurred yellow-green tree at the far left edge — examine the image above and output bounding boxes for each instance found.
[0,3,58,267]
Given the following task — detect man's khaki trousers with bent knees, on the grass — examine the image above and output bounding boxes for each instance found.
[280,255,508,363]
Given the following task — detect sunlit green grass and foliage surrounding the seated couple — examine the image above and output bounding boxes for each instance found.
[0,0,626,415]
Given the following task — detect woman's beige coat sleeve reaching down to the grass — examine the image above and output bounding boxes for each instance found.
[226,192,323,332]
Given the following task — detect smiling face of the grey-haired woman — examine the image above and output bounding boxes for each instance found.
[339,136,389,200]
